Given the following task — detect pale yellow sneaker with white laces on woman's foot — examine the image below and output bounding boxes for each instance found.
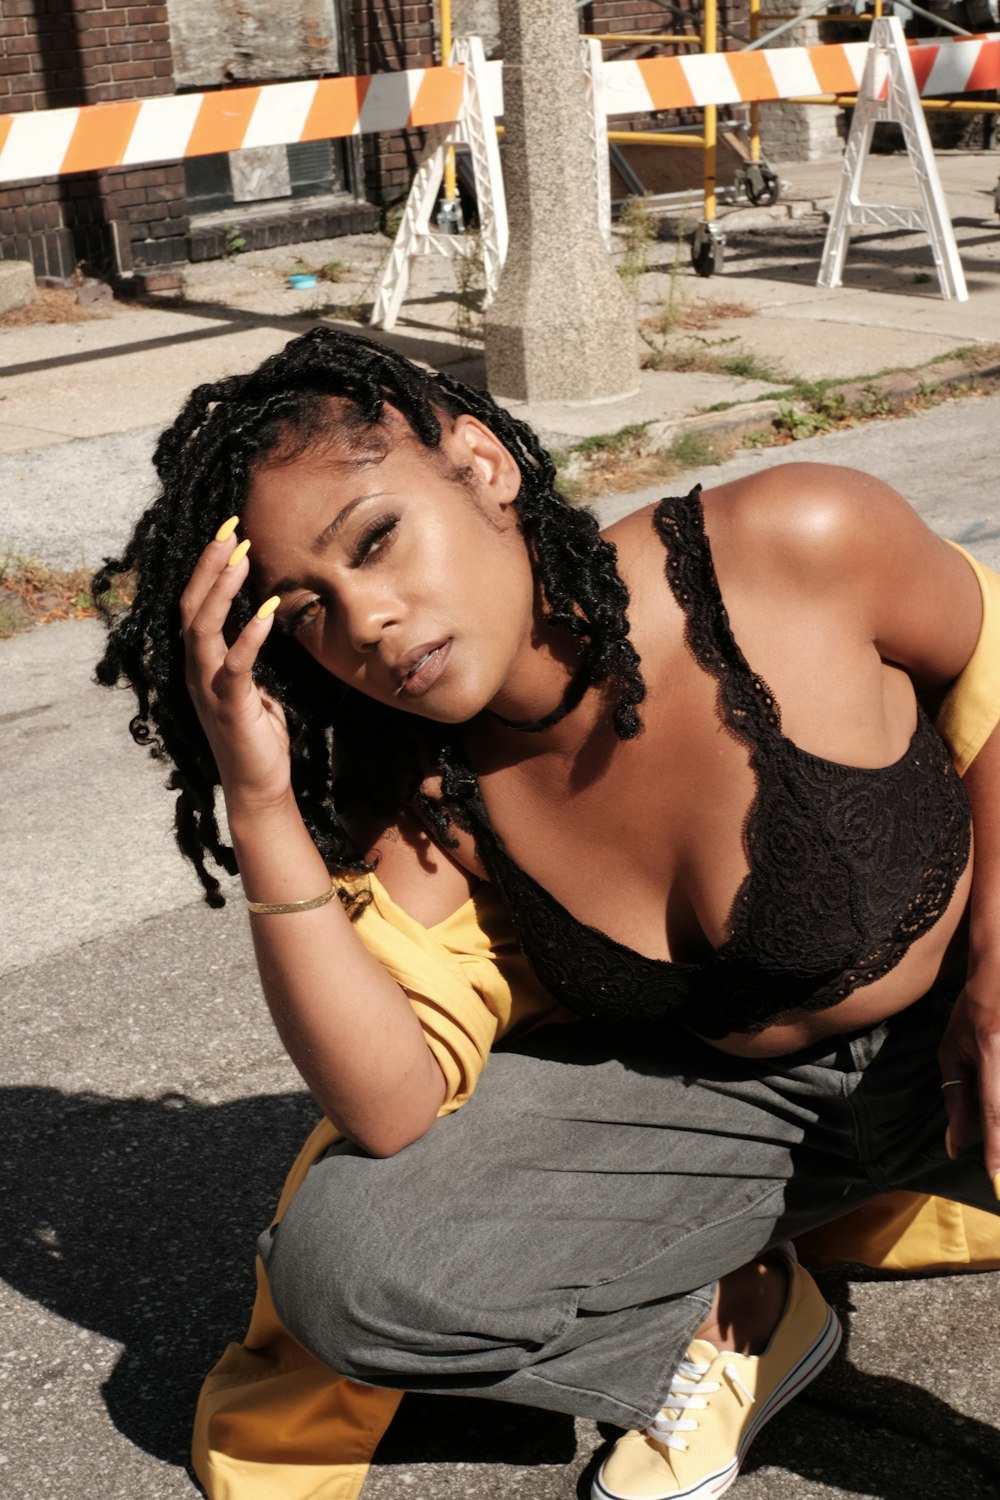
[591,1262,841,1500]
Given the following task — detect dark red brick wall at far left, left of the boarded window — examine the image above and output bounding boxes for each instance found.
[0,0,187,276]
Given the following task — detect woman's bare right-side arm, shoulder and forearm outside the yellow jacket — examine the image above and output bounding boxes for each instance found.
[722,464,1000,1197]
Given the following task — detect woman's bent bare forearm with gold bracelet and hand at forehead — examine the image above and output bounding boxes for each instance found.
[181,522,455,1157]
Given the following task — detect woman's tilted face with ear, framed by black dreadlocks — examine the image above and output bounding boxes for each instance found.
[243,413,552,723]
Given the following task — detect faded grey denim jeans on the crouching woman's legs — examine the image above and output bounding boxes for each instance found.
[259,989,1000,1427]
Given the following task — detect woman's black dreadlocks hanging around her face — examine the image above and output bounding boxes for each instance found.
[93,329,646,906]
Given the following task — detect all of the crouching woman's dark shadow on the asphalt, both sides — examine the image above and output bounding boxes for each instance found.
[0,1088,1000,1500]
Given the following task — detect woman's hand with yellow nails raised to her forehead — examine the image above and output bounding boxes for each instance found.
[180,518,291,812]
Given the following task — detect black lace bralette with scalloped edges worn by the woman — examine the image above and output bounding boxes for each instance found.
[443,486,970,1038]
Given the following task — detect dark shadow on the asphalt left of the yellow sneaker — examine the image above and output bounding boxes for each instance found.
[0,1088,576,1466]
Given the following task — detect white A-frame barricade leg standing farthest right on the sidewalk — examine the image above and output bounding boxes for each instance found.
[817,17,969,302]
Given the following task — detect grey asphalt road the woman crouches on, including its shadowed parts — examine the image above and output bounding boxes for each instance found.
[0,398,1000,1500]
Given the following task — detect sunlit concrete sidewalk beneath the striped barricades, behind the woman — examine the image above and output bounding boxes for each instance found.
[0,152,1000,465]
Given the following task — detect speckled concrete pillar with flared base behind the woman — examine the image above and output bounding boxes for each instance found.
[484,0,639,401]
